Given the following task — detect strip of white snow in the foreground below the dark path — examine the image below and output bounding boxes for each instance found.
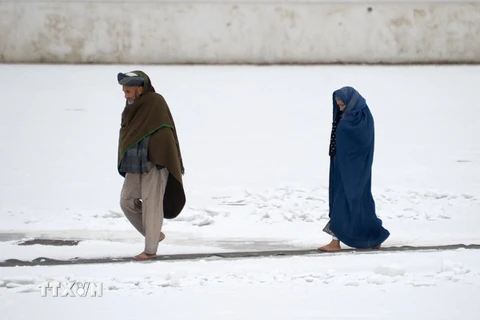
[0,250,480,320]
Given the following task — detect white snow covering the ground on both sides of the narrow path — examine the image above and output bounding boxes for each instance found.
[0,65,480,320]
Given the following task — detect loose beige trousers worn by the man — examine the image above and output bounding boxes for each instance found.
[120,162,168,254]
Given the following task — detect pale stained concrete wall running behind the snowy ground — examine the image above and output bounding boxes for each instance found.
[0,0,480,64]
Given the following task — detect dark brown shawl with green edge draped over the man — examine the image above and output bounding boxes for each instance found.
[117,71,186,219]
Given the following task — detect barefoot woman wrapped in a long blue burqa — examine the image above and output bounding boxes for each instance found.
[318,87,390,251]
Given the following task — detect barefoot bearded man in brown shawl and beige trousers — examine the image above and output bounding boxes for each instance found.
[117,71,186,260]
